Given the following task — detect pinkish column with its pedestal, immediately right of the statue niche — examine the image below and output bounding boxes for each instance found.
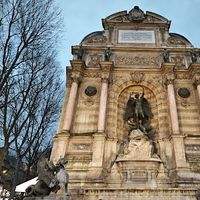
[166,72,188,173]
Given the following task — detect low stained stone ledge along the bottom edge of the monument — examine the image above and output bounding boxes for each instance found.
[81,188,197,200]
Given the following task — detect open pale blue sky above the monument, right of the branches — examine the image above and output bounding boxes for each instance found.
[55,0,200,69]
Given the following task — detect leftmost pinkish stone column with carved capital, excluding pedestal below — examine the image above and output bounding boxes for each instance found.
[63,60,85,132]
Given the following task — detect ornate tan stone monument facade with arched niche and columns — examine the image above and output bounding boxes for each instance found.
[51,6,200,200]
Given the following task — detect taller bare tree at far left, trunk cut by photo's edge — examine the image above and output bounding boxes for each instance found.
[0,0,60,166]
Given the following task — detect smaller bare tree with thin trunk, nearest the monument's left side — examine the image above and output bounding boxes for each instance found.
[7,52,63,198]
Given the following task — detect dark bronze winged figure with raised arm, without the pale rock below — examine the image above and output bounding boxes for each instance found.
[124,88,153,133]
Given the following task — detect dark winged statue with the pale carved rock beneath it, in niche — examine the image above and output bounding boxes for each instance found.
[119,86,159,160]
